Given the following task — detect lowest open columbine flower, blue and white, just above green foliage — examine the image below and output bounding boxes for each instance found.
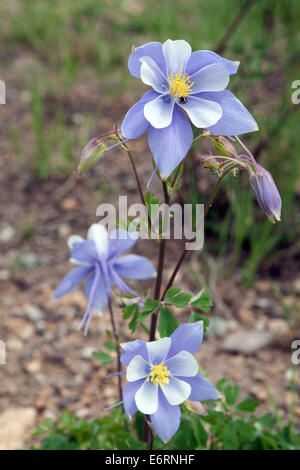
[121,322,219,442]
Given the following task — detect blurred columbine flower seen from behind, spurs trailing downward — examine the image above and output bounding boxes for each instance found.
[54,224,156,334]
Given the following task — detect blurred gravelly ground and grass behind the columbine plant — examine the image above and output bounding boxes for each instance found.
[0,0,300,448]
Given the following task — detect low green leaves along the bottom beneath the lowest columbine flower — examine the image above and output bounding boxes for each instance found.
[34,379,300,450]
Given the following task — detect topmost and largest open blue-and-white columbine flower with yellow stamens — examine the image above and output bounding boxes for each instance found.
[121,39,258,179]
